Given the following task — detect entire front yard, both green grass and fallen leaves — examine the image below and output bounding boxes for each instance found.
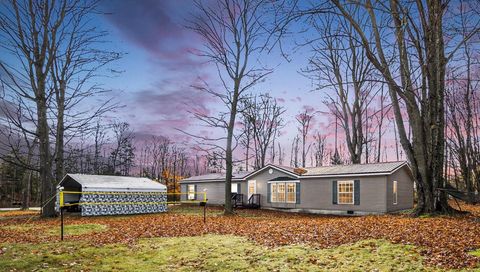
[0,206,480,271]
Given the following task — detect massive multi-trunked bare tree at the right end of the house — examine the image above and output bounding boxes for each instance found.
[322,0,479,214]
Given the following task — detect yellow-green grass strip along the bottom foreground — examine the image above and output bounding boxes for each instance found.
[0,235,446,271]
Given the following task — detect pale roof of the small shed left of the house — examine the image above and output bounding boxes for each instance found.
[59,174,167,192]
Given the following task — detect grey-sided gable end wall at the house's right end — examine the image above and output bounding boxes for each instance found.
[387,166,414,212]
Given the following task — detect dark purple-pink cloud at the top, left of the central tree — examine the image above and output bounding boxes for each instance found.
[105,0,201,70]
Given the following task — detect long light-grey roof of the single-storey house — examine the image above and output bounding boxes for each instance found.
[182,161,408,182]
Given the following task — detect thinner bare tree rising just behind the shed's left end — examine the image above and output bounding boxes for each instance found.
[50,0,120,181]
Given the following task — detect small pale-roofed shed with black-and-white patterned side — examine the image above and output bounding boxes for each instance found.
[57,174,167,216]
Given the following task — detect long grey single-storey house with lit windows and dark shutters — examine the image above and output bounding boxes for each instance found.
[180,161,414,214]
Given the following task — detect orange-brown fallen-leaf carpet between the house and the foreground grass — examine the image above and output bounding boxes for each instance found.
[0,205,480,268]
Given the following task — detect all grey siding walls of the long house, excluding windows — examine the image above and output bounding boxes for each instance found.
[181,163,413,213]
